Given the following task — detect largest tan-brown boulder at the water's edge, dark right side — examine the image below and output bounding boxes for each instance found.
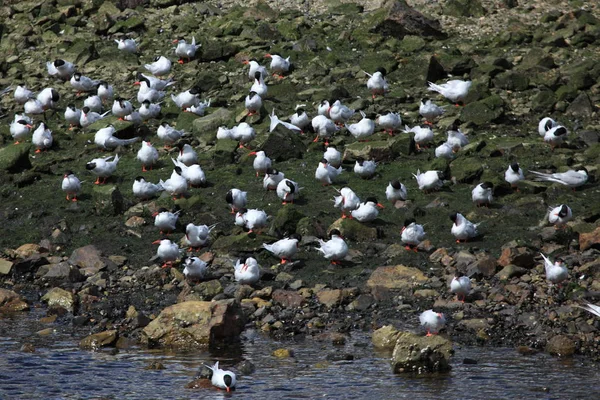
[140,299,245,348]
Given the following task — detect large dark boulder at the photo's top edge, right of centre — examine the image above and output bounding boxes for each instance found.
[373,0,446,39]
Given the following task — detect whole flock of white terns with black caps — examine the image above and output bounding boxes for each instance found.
[2,29,600,391]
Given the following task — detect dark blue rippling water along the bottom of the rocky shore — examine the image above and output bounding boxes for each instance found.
[0,311,600,400]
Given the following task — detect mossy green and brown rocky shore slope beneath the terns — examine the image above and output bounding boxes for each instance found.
[0,0,600,368]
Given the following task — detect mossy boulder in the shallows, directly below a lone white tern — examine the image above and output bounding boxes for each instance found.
[392,332,453,374]
